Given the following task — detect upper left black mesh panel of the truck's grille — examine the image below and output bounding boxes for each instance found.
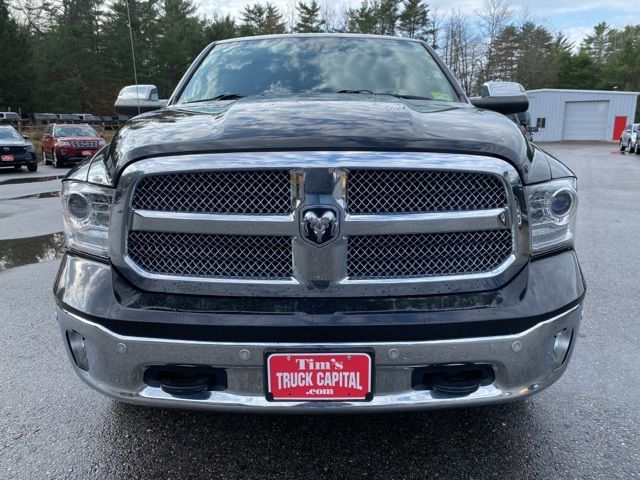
[133,170,292,215]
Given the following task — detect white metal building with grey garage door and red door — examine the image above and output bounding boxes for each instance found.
[527,88,639,142]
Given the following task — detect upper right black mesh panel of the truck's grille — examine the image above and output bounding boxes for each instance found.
[347,170,507,215]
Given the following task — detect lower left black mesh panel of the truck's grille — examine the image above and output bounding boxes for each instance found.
[128,231,292,279]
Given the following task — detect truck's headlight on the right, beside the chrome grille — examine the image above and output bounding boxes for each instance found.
[526,178,578,254]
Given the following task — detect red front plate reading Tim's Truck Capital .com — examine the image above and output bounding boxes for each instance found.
[267,352,372,401]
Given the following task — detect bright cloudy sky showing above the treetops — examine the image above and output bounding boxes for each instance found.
[195,0,640,42]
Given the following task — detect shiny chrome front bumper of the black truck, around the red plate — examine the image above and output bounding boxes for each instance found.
[56,305,582,413]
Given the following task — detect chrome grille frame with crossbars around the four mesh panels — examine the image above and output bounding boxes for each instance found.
[110,151,530,297]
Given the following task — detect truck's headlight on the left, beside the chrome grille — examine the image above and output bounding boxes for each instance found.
[62,181,113,258]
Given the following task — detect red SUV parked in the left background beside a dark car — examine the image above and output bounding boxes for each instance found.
[42,123,106,167]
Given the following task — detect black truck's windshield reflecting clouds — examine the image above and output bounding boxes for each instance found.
[179,37,457,103]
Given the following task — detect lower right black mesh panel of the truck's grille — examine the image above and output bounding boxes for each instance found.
[347,230,513,279]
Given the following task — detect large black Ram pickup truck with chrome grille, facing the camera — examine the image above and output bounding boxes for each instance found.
[54,34,585,412]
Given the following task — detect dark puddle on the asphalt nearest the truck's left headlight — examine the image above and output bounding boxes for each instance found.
[0,232,64,272]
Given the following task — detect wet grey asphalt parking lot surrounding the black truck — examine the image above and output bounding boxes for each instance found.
[0,143,640,479]
